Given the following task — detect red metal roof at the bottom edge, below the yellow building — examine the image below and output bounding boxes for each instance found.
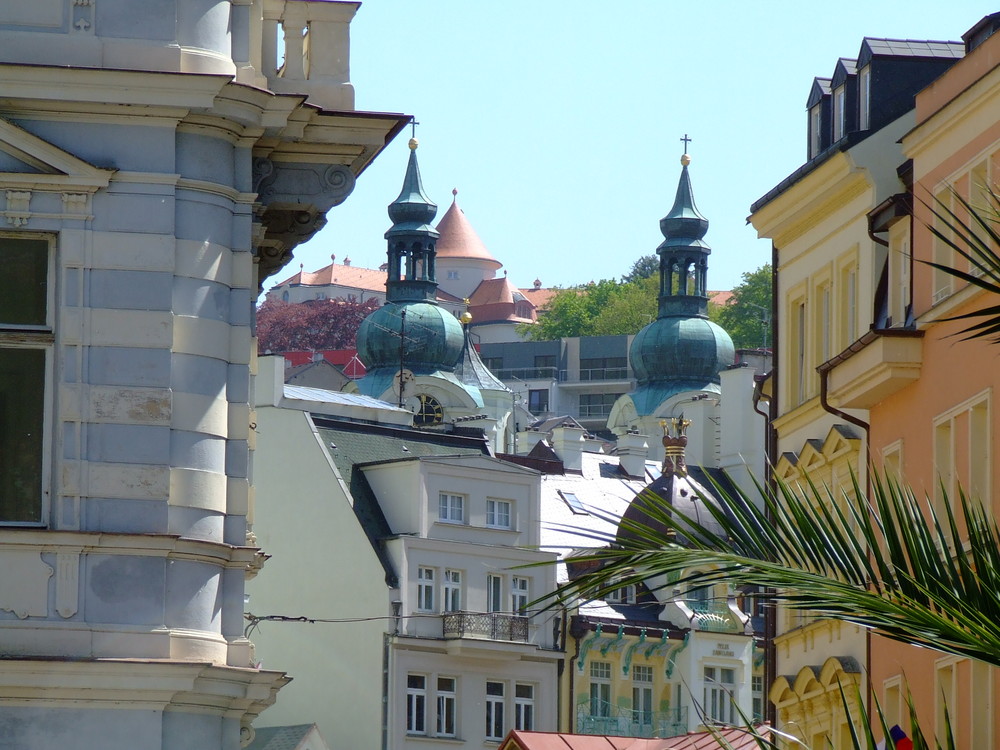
[499,724,771,750]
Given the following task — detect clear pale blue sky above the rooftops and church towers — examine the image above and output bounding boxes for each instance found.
[282,0,996,296]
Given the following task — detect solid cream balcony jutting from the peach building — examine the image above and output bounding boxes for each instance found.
[820,328,923,409]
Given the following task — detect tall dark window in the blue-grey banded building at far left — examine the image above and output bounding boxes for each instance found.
[0,237,53,524]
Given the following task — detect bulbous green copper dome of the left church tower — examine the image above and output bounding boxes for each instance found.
[357,302,465,375]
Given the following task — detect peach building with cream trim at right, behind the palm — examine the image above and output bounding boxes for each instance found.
[830,14,1000,750]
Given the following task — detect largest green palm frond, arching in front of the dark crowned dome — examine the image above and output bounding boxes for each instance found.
[555,472,1000,666]
